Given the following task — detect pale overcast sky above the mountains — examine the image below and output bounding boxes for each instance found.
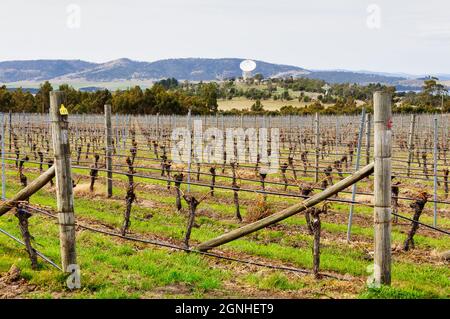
[0,0,450,74]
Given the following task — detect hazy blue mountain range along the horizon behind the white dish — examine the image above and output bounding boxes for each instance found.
[0,58,450,87]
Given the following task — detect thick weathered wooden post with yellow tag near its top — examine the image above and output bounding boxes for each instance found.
[50,91,76,272]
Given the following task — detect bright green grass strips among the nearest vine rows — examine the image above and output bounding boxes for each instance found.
[0,154,450,298]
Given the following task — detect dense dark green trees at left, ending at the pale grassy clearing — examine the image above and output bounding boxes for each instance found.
[0,80,218,114]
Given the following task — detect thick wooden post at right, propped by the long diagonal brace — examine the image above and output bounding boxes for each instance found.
[373,92,392,285]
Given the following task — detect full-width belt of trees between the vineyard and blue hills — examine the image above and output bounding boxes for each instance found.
[0,75,450,115]
